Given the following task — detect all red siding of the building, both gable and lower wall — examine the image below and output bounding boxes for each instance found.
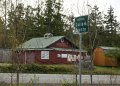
[20,35,86,65]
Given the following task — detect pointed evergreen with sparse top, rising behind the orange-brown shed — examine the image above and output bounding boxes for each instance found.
[104,6,119,46]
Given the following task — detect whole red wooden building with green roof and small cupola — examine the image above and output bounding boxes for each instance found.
[19,33,87,64]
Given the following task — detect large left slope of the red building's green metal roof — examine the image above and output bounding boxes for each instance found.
[20,36,65,48]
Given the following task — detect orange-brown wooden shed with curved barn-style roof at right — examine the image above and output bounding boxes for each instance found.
[93,46,117,66]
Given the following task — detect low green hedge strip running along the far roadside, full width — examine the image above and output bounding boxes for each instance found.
[0,63,120,75]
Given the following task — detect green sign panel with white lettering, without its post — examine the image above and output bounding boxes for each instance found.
[74,15,88,34]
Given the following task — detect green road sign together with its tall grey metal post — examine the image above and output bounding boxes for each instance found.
[74,15,88,86]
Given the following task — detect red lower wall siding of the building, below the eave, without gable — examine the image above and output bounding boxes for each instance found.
[20,51,86,65]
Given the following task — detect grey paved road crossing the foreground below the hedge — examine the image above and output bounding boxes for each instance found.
[0,73,120,84]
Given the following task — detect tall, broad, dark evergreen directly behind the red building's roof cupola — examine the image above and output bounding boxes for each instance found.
[44,0,66,36]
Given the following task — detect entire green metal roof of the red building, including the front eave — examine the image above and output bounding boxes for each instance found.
[17,36,87,52]
